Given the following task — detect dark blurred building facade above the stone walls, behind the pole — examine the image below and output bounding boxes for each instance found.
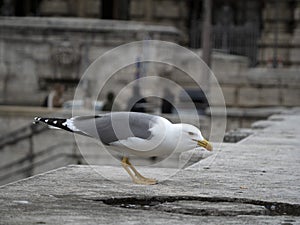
[0,0,300,67]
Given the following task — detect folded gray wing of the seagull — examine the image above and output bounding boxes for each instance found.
[72,112,158,145]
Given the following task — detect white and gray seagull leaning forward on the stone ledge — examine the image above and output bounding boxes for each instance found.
[34,112,213,185]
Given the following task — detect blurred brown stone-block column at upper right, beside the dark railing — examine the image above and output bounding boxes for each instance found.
[258,0,293,67]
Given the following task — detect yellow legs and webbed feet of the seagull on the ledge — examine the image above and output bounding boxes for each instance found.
[122,157,157,185]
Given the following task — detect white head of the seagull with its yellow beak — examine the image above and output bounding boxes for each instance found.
[181,124,213,151]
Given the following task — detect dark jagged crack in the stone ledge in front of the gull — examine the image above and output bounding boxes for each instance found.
[94,196,300,216]
